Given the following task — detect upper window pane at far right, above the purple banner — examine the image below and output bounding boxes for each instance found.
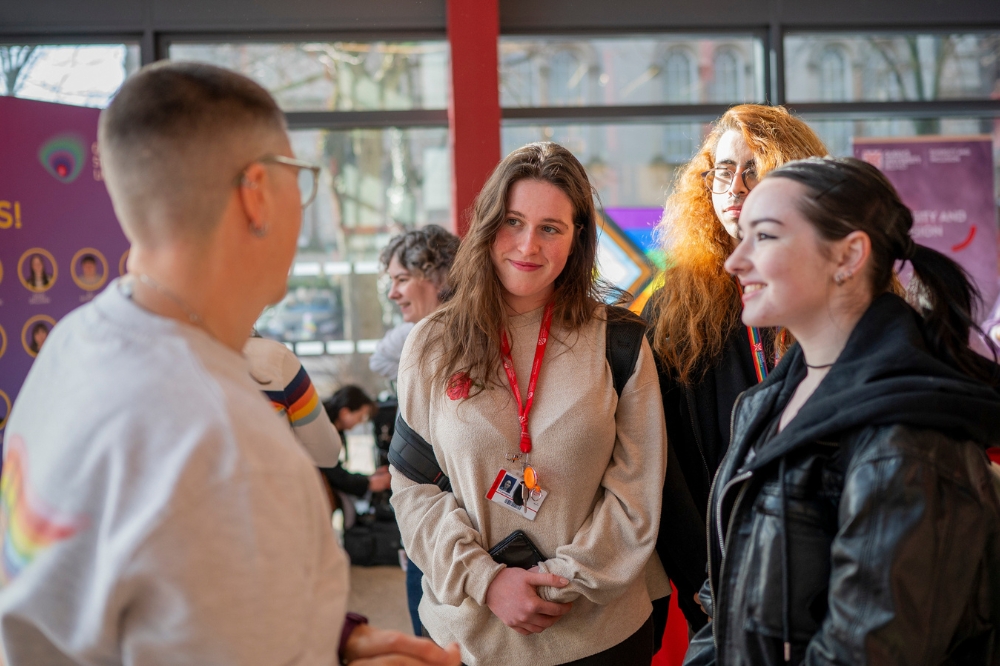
[785,32,1000,102]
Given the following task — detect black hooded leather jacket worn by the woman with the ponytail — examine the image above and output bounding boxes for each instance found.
[685,294,1000,665]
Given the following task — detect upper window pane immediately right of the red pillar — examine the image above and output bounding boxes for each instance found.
[500,35,764,108]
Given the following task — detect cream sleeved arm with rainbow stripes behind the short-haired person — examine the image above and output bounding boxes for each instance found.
[243,335,341,467]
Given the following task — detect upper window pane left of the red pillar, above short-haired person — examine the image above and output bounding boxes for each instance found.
[169,40,448,111]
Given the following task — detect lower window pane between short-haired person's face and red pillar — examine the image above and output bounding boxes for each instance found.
[257,128,451,392]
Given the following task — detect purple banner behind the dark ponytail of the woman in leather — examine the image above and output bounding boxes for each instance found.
[854,136,1000,320]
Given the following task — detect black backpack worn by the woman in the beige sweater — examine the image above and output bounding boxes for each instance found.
[389,306,646,492]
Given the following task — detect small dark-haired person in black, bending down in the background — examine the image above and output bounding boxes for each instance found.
[320,384,391,516]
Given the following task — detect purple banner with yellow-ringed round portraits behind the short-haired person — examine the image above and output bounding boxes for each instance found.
[0,97,128,441]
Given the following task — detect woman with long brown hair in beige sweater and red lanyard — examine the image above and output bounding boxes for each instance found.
[390,143,669,666]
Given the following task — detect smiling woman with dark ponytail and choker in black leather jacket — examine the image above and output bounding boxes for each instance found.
[685,159,1000,666]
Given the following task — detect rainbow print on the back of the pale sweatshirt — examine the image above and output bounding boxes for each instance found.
[0,435,80,587]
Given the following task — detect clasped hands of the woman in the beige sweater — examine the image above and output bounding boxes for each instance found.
[486,567,573,636]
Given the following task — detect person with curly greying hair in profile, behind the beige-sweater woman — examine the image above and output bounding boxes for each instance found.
[368,224,460,382]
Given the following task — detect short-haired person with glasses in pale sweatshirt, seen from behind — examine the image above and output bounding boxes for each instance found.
[0,62,459,666]
